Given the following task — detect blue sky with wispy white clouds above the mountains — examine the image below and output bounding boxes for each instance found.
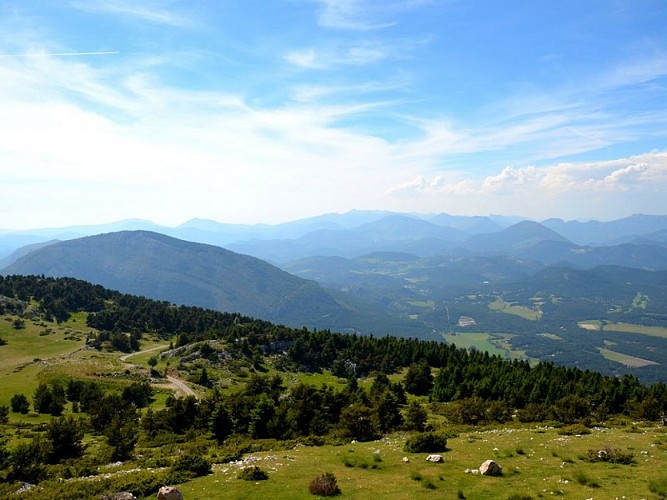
[0,0,667,229]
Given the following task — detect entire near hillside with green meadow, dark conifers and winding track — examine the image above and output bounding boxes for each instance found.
[0,276,667,499]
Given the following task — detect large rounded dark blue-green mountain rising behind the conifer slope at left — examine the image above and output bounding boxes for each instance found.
[2,231,404,328]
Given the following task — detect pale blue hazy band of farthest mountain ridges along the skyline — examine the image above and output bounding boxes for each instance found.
[5,210,667,267]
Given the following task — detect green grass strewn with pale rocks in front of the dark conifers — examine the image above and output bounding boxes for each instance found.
[172,427,667,500]
